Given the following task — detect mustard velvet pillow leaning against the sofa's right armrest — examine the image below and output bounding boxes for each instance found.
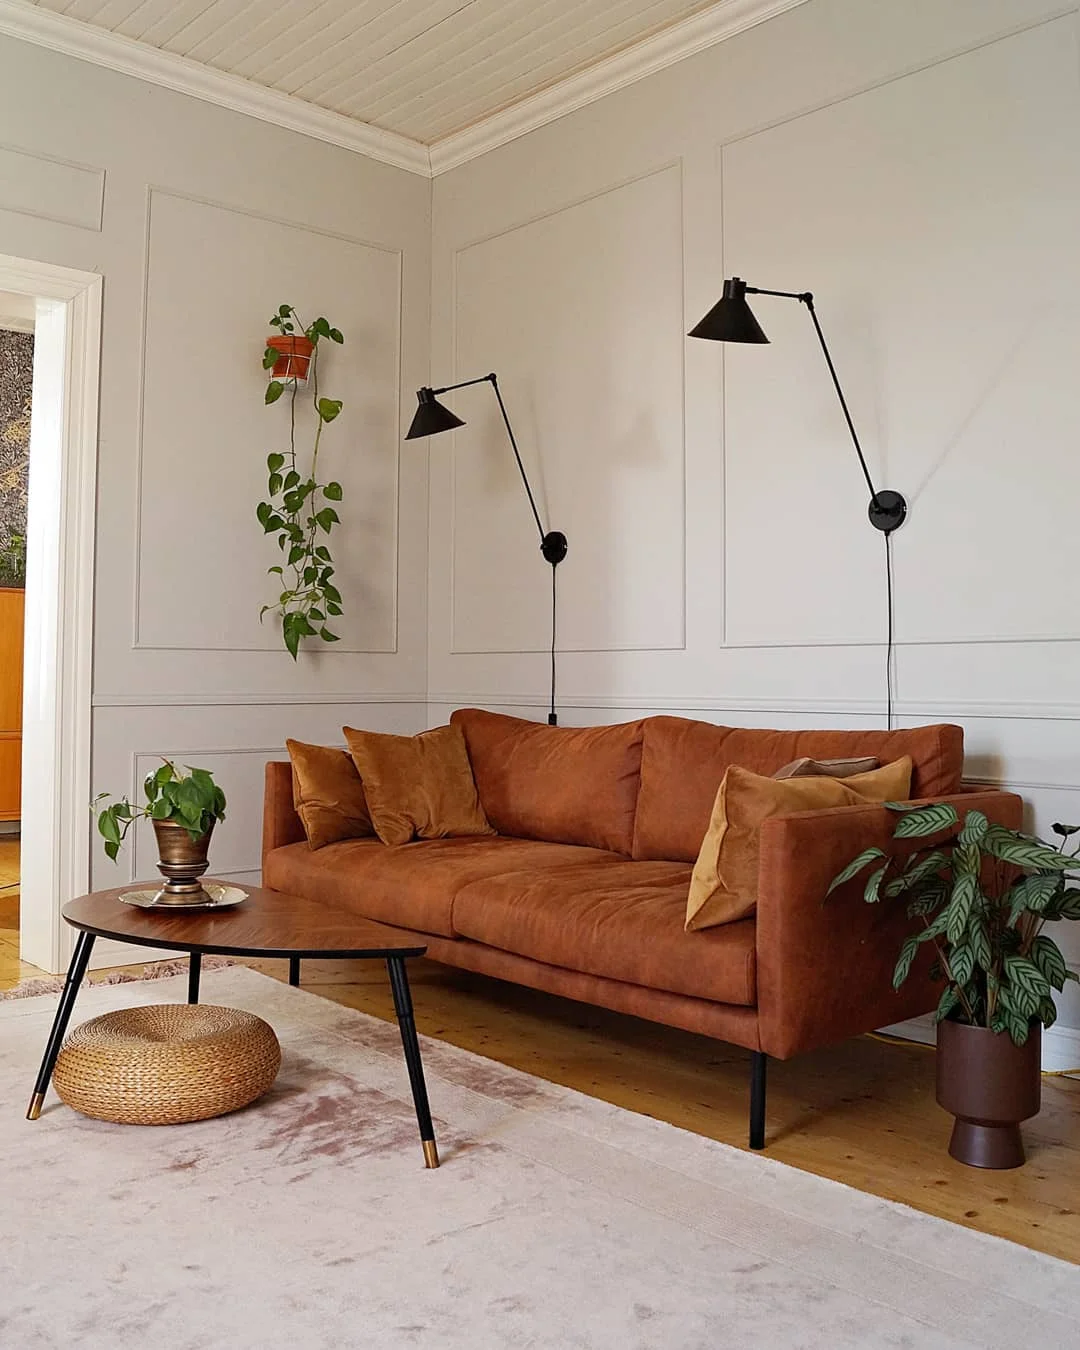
[686,755,911,930]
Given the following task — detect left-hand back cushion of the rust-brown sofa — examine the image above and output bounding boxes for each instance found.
[451,707,645,857]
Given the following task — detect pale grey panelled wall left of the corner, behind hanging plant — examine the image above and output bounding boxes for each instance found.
[0,39,431,939]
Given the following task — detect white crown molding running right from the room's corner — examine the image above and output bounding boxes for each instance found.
[431,0,806,177]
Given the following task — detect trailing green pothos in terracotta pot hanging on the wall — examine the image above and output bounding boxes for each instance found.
[257,305,344,660]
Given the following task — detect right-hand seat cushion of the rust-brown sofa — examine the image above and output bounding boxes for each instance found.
[454,863,756,1007]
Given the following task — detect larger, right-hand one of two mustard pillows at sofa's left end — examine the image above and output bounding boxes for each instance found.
[344,726,495,844]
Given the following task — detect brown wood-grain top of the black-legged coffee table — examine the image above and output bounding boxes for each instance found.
[62,882,427,957]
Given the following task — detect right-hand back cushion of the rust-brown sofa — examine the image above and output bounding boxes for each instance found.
[633,717,964,863]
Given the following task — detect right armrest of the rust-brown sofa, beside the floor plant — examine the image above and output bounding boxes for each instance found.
[756,790,1023,1060]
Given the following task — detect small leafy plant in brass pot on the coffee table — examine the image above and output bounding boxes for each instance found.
[90,760,225,905]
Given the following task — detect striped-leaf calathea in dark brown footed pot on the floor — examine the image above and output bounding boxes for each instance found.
[829,802,1080,1168]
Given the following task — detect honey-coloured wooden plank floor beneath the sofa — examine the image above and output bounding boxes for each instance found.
[0,842,1080,1262]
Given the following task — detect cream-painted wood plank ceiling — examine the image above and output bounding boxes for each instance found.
[35,0,724,144]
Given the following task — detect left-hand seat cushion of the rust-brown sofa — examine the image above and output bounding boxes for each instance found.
[262,836,623,937]
